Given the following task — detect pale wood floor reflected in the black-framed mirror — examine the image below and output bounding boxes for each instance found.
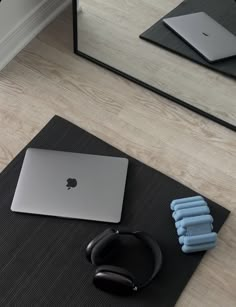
[75,0,236,126]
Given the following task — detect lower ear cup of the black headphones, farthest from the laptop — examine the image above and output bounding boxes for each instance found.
[93,265,135,295]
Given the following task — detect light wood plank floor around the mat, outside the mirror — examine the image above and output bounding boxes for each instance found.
[0,4,236,307]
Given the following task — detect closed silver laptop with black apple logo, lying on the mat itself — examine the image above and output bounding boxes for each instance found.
[11,148,128,223]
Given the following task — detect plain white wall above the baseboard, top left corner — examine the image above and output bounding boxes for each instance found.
[0,0,45,41]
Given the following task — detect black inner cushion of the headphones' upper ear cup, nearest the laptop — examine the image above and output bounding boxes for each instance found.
[91,233,119,265]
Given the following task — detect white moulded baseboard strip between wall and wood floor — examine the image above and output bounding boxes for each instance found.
[0,0,72,70]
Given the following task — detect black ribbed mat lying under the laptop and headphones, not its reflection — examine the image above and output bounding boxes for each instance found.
[0,116,229,307]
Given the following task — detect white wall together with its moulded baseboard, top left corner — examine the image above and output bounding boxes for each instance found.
[0,0,72,70]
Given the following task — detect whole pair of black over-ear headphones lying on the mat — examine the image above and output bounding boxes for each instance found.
[86,228,162,295]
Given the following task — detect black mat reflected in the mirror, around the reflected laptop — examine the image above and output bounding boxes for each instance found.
[140,0,236,78]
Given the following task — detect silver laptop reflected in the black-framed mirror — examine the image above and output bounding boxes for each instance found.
[163,12,236,62]
